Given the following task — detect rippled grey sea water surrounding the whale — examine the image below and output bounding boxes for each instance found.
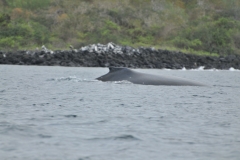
[0,65,240,160]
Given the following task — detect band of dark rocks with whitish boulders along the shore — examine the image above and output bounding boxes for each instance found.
[0,43,240,69]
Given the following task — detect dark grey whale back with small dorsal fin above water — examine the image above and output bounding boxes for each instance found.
[96,67,206,86]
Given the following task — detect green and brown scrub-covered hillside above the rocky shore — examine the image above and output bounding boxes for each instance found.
[0,0,240,56]
